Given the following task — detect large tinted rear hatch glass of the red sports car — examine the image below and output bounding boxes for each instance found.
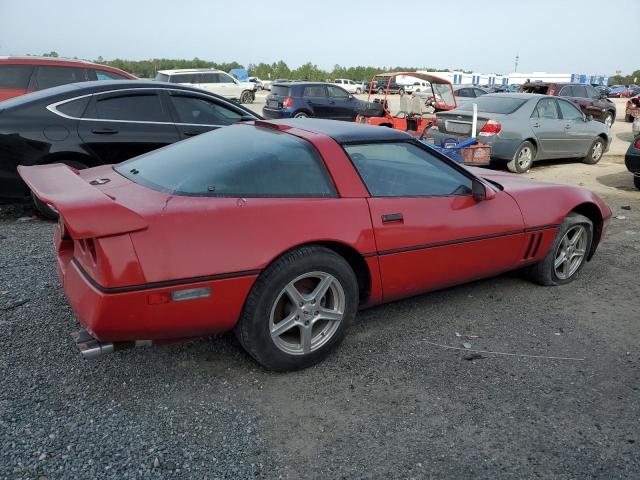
[115,125,336,197]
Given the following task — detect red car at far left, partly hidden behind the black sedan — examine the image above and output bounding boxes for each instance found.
[0,57,136,101]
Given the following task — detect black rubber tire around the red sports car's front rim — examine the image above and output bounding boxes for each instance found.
[525,212,593,286]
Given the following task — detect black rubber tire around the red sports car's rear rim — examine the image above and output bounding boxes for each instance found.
[234,246,358,371]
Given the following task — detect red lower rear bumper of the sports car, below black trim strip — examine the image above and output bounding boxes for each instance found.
[57,258,257,342]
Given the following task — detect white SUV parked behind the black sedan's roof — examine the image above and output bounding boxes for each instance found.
[156,68,256,103]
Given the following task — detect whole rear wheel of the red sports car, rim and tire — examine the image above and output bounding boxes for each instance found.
[235,246,358,371]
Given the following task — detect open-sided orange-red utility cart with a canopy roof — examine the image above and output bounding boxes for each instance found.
[356,72,457,136]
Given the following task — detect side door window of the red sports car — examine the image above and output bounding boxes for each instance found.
[345,142,471,197]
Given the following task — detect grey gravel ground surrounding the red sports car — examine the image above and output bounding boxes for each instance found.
[0,159,640,479]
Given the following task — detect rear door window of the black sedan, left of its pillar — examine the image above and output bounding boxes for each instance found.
[95,94,170,122]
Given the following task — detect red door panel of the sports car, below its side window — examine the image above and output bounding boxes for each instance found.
[368,192,525,301]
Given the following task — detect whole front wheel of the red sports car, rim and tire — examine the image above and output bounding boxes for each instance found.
[525,213,593,285]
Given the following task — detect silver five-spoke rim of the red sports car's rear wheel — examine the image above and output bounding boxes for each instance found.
[269,271,346,355]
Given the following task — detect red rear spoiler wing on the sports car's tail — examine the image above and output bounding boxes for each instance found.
[18,163,148,239]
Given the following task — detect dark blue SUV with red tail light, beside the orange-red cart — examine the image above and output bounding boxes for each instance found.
[262,82,363,122]
